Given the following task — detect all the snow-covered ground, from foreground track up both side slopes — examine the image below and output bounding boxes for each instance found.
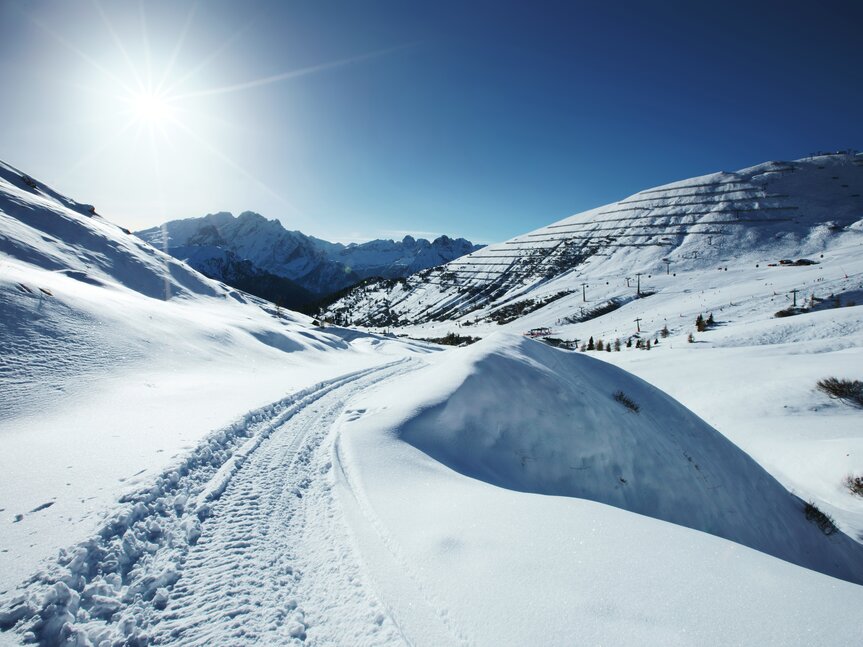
[0,158,863,646]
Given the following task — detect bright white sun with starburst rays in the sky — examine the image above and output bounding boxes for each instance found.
[22,0,411,218]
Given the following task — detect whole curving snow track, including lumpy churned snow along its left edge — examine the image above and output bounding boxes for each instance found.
[0,360,416,645]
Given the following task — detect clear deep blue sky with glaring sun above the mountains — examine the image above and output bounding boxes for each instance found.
[0,0,863,242]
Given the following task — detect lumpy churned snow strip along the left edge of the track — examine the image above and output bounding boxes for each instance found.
[0,360,412,645]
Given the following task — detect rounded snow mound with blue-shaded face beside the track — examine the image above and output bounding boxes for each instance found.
[372,334,863,583]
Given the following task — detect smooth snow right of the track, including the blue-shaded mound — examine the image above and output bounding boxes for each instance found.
[337,336,863,645]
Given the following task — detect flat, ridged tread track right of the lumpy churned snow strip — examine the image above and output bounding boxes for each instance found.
[152,366,416,645]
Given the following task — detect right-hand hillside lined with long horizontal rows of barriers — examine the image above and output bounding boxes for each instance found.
[327,153,863,326]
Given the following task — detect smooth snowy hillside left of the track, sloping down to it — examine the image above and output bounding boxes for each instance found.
[0,164,430,612]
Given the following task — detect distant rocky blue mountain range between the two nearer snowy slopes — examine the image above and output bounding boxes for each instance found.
[135,211,482,307]
